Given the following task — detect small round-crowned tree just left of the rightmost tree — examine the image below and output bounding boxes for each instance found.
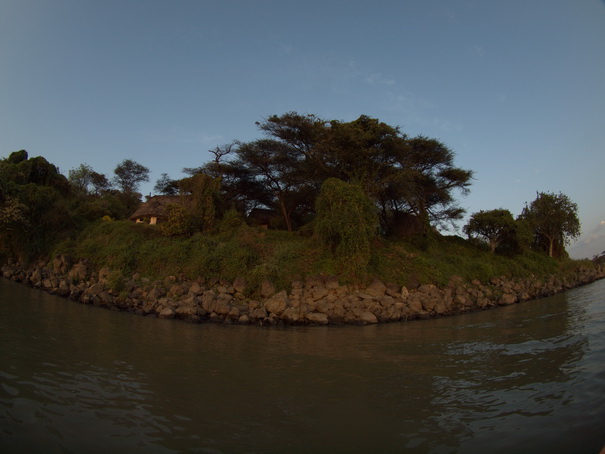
[464,208,515,253]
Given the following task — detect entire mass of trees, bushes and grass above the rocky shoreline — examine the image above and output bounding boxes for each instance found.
[0,112,596,285]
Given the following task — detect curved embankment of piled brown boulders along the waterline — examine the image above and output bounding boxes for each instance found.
[1,256,605,325]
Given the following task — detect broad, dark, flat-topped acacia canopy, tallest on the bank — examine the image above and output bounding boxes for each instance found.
[196,112,473,234]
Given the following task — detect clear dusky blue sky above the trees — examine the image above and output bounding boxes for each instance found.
[0,0,605,258]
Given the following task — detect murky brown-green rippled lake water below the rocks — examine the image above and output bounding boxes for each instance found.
[0,279,605,454]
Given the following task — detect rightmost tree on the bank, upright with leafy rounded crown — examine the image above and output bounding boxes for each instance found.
[520,192,580,257]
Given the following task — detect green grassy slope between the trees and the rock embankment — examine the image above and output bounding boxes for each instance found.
[54,221,593,289]
